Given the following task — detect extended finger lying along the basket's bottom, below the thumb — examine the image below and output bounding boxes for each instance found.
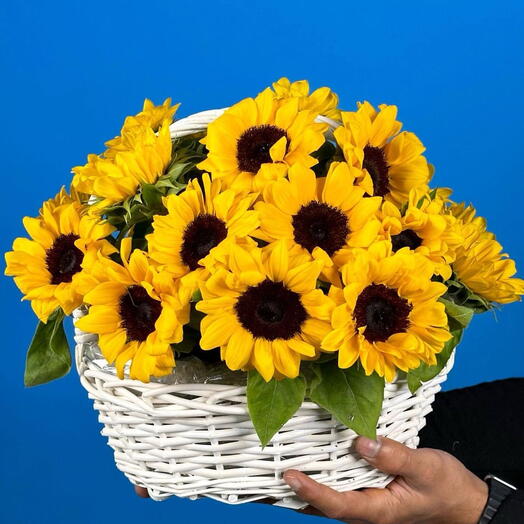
[284,470,379,521]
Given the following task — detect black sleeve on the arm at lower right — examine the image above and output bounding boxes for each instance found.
[419,378,524,488]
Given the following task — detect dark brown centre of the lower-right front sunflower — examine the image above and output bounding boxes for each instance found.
[353,284,413,342]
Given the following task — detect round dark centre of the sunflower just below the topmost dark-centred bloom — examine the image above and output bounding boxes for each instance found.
[292,201,349,256]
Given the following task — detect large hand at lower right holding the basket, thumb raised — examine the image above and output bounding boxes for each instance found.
[284,437,488,524]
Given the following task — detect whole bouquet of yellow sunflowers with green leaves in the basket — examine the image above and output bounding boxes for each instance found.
[6,78,524,445]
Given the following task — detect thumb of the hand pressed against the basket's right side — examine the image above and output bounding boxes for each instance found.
[355,437,421,477]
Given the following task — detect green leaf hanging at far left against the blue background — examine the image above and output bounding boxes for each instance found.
[24,308,71,386]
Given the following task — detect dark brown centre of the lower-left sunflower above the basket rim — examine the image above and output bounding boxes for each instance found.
[118,286,162,342]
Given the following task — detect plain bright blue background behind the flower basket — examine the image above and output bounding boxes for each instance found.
[0,0,524,524]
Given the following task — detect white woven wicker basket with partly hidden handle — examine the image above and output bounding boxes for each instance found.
[74,109,454,508]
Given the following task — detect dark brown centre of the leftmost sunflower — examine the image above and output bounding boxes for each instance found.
[45,233,84,285]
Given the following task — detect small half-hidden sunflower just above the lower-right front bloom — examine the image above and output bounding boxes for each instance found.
[372,189,463,280]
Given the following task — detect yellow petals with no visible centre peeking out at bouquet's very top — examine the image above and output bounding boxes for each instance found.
[273,77,340,120]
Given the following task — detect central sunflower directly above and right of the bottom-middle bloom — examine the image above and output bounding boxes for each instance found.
[255,162,382,280]
